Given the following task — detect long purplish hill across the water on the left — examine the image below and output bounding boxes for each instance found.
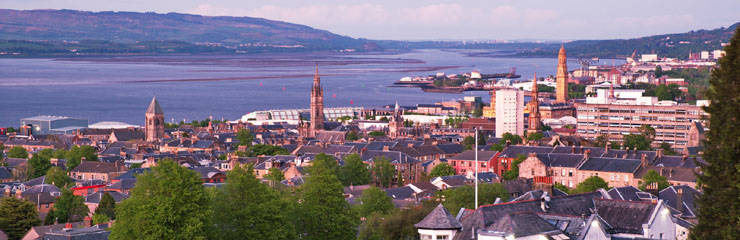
[0,9,374,52]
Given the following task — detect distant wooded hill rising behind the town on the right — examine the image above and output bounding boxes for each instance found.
[520,23,740,59]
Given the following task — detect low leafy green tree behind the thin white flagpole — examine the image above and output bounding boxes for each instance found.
[440,183,509,215]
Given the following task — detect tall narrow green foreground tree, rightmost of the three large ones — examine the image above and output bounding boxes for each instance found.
[297,150,359,240]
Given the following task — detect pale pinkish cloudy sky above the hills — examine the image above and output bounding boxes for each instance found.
[5,0,740,41]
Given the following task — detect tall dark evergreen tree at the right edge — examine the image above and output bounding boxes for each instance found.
[690,26,740,239]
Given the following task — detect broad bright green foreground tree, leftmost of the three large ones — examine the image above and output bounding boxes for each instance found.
[109,159,211,240]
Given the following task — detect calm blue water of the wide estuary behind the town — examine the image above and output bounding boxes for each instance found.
[0,50,612,126]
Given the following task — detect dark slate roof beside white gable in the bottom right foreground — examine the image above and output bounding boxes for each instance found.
[593,199,656,235]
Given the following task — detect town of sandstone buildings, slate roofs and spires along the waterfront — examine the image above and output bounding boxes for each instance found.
[0,41,724,239]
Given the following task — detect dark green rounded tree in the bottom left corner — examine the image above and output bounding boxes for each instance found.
[0,197,41,239]
